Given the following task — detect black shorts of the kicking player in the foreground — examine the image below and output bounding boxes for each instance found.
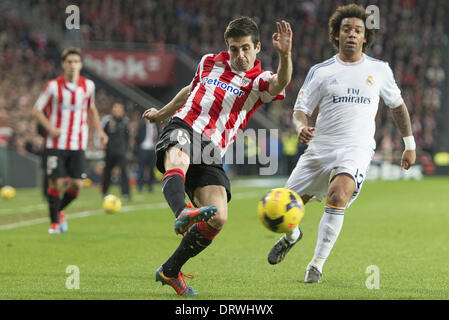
[156,117,231,205]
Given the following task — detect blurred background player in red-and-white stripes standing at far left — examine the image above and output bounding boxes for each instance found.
[33,48,108,234]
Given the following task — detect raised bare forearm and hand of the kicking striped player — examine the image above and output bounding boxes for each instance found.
[268,20,293,96]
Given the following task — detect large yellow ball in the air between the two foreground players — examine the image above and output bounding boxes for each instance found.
[258,188,304,233]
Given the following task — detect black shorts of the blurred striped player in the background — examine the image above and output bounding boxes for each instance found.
[46,149,86,179]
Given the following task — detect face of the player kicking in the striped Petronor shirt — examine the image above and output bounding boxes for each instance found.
[227,36,260,71]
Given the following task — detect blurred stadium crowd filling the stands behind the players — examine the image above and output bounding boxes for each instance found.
[0,0,449,175]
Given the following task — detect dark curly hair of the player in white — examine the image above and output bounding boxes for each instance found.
[329,3,376,51]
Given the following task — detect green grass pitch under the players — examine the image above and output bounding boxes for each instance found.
[0,178,449,300]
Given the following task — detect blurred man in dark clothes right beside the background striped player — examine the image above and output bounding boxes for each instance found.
[102,103,130,200]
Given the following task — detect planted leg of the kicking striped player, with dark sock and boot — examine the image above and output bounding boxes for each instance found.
[156,185,228,295]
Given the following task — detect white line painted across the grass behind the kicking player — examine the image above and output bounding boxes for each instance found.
[0,191,262,230]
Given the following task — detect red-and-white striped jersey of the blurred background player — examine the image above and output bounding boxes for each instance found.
[34,75,95,150]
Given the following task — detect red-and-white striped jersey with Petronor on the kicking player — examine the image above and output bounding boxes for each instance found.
[174,52,285,156]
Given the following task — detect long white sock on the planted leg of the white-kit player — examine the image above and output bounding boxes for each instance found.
[307,206,344,272]
